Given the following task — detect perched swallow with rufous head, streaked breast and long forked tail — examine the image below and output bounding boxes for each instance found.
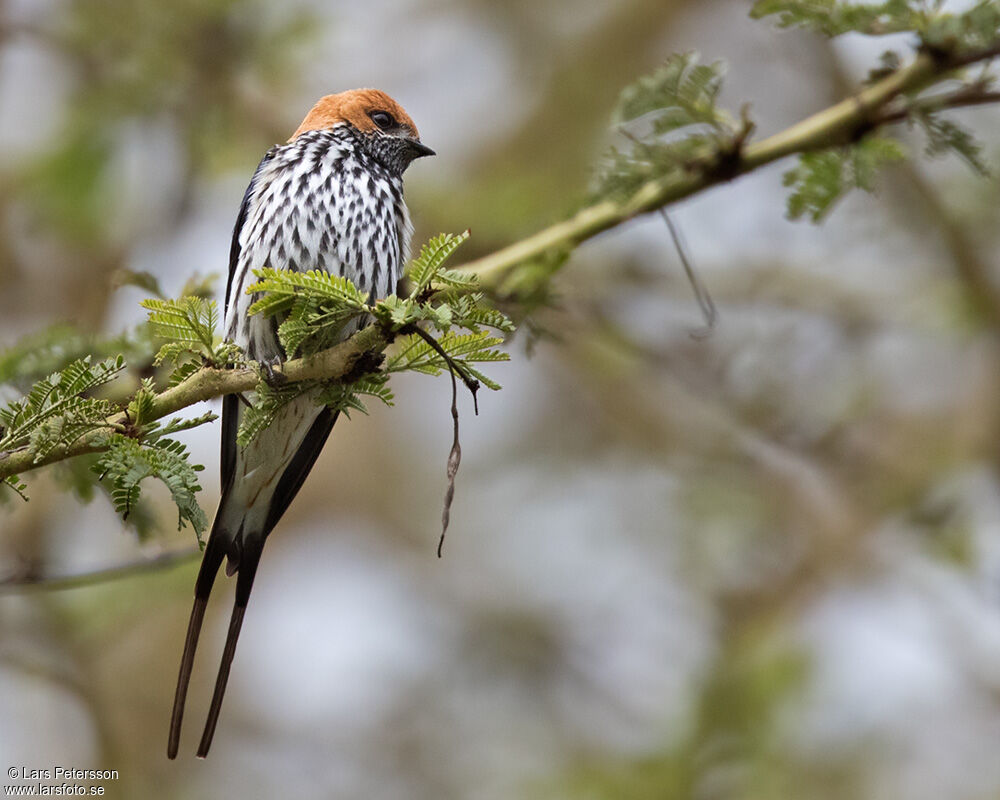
[167,89,435,759]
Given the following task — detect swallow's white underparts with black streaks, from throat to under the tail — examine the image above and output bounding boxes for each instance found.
[222,125,412,536]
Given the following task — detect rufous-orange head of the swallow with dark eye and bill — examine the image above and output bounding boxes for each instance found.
[288,89,434,172]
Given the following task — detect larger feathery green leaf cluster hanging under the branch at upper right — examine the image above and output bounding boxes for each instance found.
[784,135,906,222]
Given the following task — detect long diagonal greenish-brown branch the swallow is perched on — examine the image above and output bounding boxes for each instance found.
[0,43,1000,488]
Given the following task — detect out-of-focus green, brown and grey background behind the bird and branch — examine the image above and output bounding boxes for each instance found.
[0,0,1000,800]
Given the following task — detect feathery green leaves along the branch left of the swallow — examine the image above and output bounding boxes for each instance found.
[0,294,223,533]
